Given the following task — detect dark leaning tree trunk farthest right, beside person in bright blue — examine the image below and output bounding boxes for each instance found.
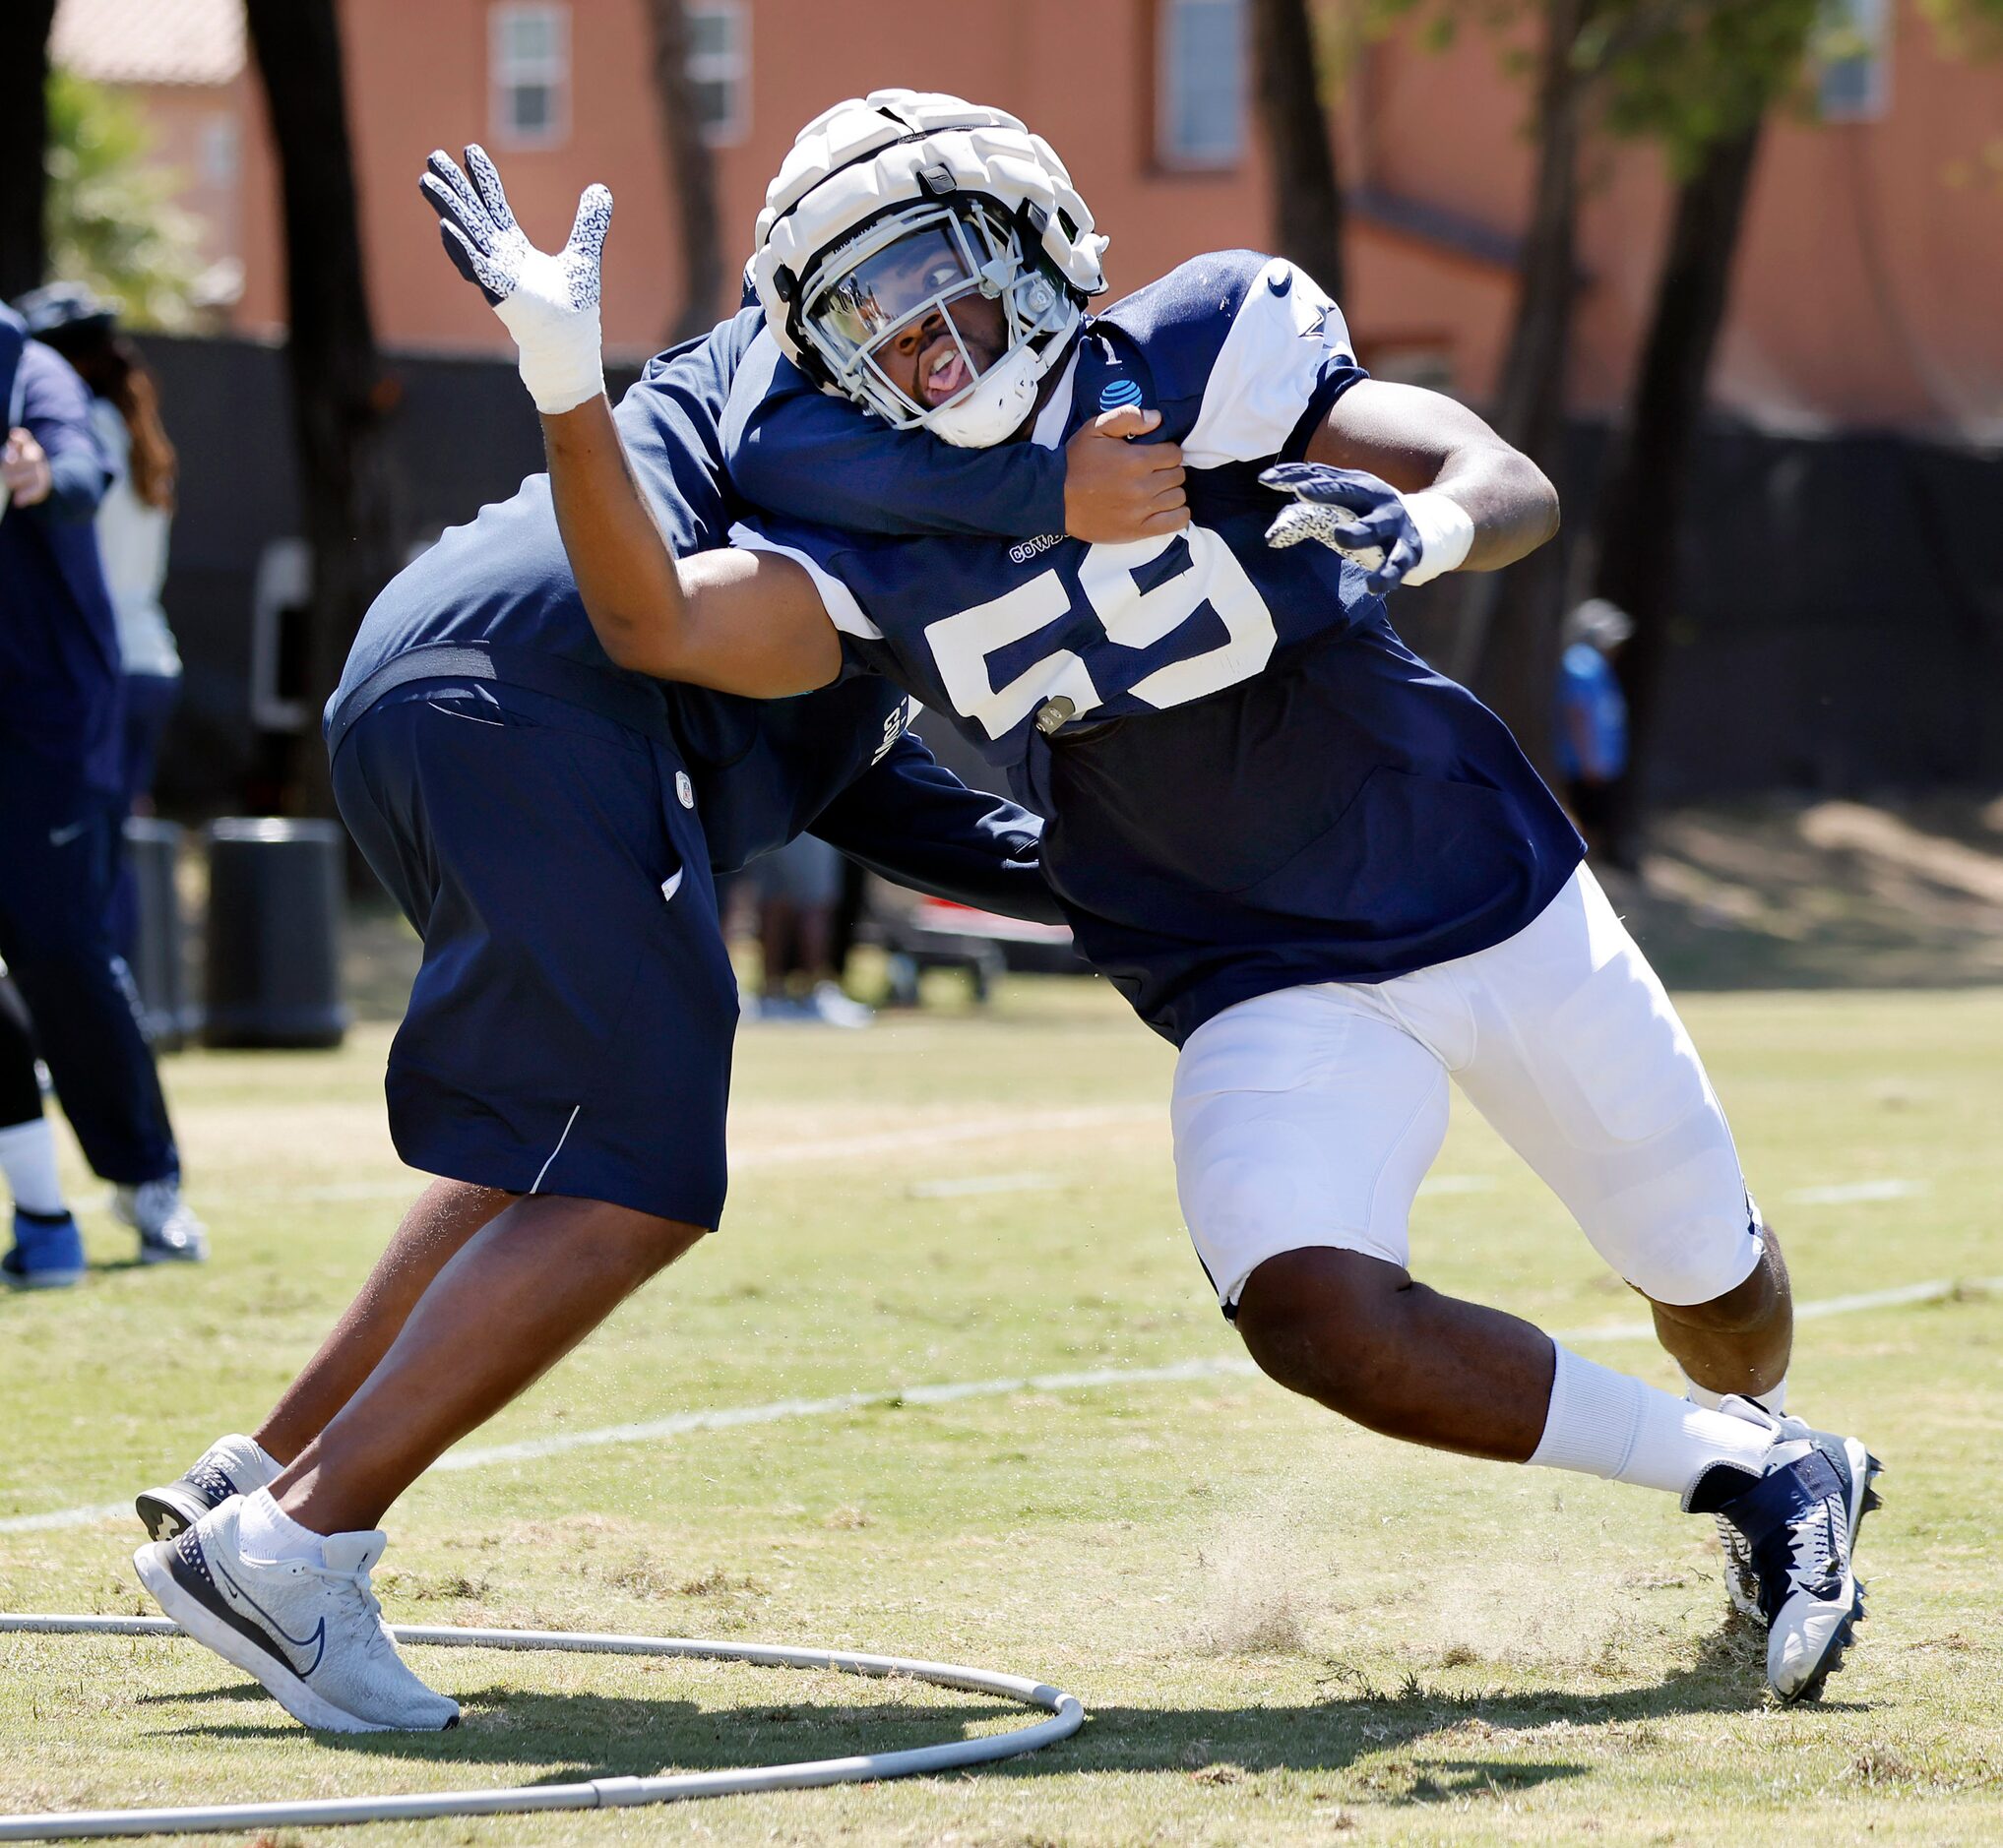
[1593,118,1763,865]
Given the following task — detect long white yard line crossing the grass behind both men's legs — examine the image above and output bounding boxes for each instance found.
[0,1277,2003,1534]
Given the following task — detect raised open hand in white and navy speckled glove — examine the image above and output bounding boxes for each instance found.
[418,144,613,416]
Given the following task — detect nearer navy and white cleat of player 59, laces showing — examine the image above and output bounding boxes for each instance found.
[1684,1420,1881,1701]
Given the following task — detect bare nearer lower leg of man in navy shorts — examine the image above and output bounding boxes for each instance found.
[273,1196,703,1534]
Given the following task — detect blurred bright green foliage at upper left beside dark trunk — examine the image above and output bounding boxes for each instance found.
[48,70,203,329]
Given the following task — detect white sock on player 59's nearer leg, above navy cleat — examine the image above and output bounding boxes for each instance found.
[1531,1341,1773,1496]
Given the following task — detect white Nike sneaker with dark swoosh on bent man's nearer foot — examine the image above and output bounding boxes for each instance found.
[132,1496,459,1732]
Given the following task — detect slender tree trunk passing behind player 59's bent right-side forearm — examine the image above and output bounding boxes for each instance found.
[1450,0,1596,774]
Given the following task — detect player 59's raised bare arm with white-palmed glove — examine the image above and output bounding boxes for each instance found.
[420,147,842,699]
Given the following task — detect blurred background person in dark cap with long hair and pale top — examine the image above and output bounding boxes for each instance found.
[20,282,180,959]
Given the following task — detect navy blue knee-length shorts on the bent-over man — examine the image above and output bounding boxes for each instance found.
[335,681,737,1227]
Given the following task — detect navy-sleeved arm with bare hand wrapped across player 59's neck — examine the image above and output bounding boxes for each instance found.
[723,339,1190,544]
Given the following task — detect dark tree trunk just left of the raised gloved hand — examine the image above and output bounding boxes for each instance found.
[244,0,398,815]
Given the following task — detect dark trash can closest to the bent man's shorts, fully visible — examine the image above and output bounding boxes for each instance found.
[203,817,348,1047]
